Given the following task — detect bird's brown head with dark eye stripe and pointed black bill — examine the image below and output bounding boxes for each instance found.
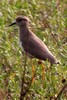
[9,16,30,27]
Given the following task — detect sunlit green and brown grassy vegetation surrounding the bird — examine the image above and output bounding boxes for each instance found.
[0,0,67,100]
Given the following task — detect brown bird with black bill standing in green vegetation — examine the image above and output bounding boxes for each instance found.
[9,16,58,82]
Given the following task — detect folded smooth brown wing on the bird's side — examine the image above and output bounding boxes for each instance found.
[28,31,51,60]
